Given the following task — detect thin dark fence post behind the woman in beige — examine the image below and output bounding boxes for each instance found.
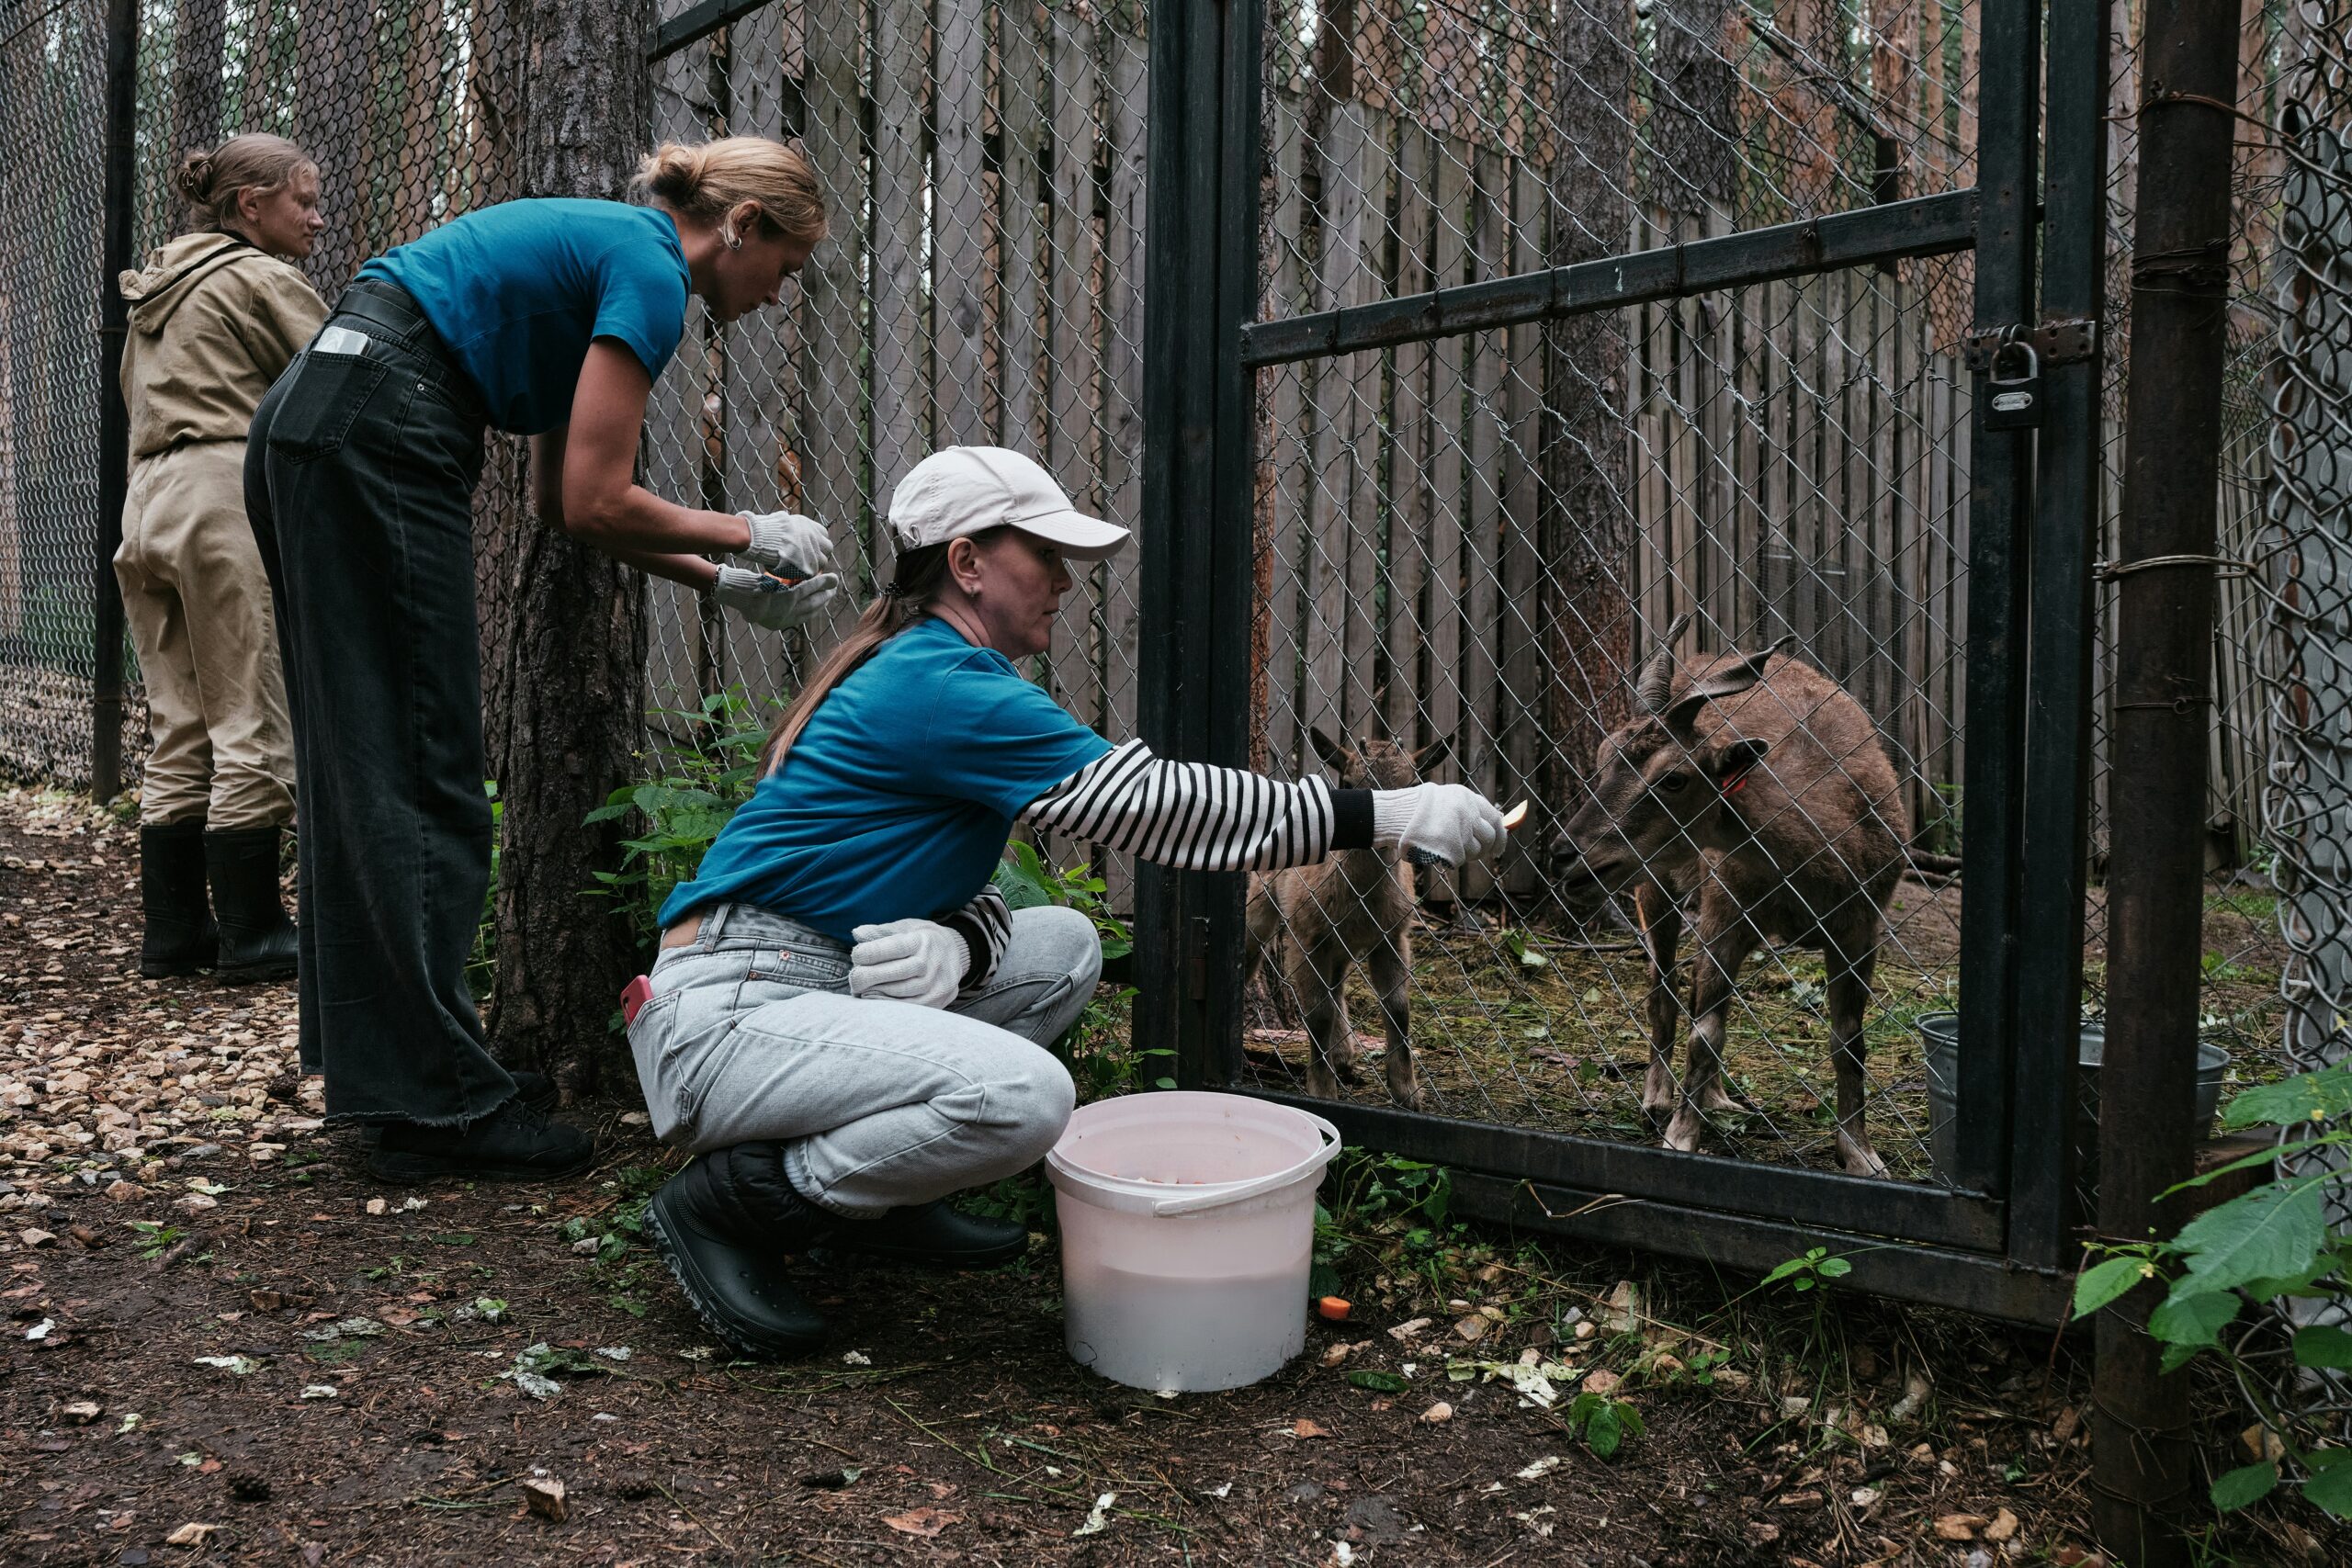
[89,0,139,799]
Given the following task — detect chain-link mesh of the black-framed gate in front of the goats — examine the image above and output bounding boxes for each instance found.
[1249,0,1978,1178]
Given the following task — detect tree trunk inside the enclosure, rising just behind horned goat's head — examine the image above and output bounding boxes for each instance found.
[1538,0,1634,816]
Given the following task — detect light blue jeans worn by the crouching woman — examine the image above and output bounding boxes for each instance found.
[628,903,1103,1218]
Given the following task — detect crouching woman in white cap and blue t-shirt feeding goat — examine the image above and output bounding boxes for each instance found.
[628,446,1503,1357]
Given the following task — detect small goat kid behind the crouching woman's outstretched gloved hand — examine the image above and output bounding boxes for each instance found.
[1242,728,1444,1110]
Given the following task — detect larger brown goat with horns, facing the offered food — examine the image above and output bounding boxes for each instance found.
[1553,616,1910,1176]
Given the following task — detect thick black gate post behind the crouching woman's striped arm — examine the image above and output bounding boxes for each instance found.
[1136,0,1261,1089]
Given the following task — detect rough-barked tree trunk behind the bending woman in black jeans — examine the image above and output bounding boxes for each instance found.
[478,0,651,1100]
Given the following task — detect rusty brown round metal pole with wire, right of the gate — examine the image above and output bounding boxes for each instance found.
[2091,0,2239,1568]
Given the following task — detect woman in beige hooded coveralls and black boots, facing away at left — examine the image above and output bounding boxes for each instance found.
[115,136,327,983]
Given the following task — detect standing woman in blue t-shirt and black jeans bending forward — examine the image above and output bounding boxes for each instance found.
[244,136,837,1180]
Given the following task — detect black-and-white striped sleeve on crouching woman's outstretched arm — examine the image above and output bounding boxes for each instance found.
[1021,740,1371,872]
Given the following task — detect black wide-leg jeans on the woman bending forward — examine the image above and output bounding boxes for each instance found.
[244,280,515,1126]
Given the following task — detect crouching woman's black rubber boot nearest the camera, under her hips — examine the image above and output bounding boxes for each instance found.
[644,1143,831,1361]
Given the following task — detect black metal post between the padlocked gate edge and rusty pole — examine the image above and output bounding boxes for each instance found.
[2008,0,2108,1269]
